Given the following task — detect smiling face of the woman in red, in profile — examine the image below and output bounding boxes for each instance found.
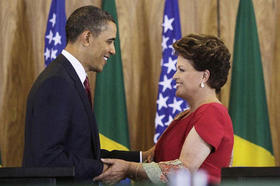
[173,55,203,99]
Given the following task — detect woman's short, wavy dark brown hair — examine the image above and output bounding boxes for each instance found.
[173,34,231,92]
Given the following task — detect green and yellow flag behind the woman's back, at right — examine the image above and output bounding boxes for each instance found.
[229,0,275,166]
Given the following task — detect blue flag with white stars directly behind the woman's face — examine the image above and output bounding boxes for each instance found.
[154,0,187,143]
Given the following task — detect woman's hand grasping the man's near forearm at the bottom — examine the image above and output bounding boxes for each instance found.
[93,159,130,184]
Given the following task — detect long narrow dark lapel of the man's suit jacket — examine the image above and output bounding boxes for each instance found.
[59,55,100,159]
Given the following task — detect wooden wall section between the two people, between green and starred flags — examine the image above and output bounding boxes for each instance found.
[117,0,163,149]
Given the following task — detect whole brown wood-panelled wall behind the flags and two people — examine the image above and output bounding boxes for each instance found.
[0,0,280,166]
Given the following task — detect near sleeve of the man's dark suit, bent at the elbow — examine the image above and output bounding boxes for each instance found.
[25,77,103,179]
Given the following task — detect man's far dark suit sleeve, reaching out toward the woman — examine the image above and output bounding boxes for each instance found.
[101,149,140,162]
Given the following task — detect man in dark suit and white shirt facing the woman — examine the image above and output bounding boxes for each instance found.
[23,6,139,179]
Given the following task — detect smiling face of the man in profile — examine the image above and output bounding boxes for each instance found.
[86,21,117,72]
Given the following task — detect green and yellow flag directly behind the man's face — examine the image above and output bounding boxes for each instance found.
[94,0,129,150]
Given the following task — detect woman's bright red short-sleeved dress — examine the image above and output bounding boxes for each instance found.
[154,103,233,183]
